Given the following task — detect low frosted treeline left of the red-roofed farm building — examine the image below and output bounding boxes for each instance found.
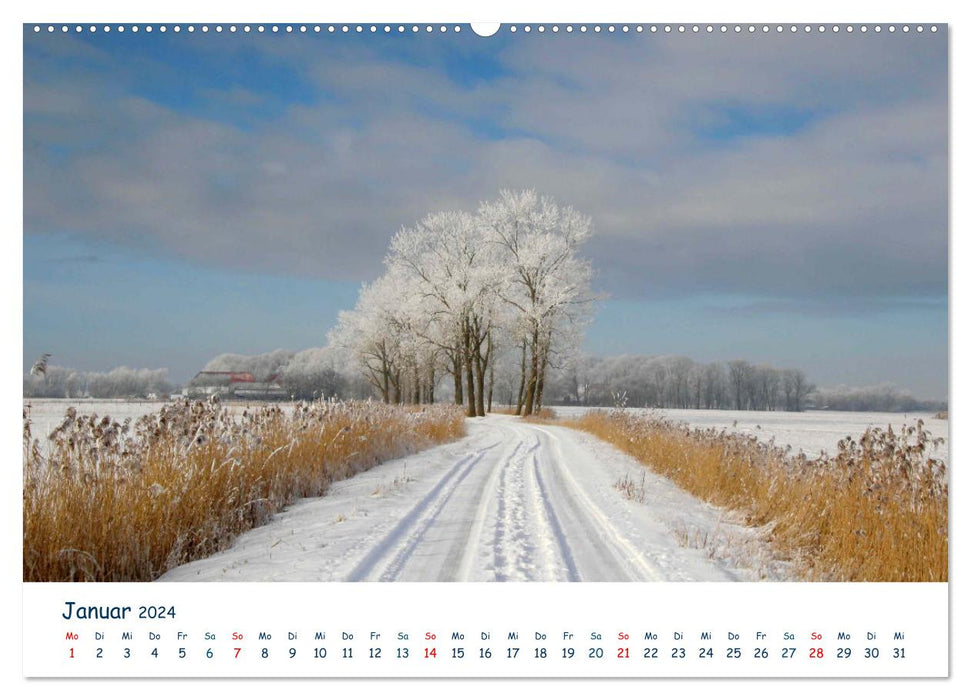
[24,365,176,399]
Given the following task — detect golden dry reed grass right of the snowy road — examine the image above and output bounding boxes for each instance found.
[564,410,948,581]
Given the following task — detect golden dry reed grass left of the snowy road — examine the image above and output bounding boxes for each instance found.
[23,401,465,581]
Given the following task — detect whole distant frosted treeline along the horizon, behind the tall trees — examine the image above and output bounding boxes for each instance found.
[24,347,947,412]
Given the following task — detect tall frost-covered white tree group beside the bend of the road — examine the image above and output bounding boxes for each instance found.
[330,190,592,416]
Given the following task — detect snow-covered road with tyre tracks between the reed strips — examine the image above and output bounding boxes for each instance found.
[161,416,774,581]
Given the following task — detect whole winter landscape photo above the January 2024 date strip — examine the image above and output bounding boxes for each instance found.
[22,24,948,582]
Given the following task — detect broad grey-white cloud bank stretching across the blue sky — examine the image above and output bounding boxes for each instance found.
[25,29,947,306]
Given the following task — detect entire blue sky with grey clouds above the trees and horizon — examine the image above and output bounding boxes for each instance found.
[24,28,948,398]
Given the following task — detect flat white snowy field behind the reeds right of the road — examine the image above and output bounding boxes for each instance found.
[553,406,948,462]
